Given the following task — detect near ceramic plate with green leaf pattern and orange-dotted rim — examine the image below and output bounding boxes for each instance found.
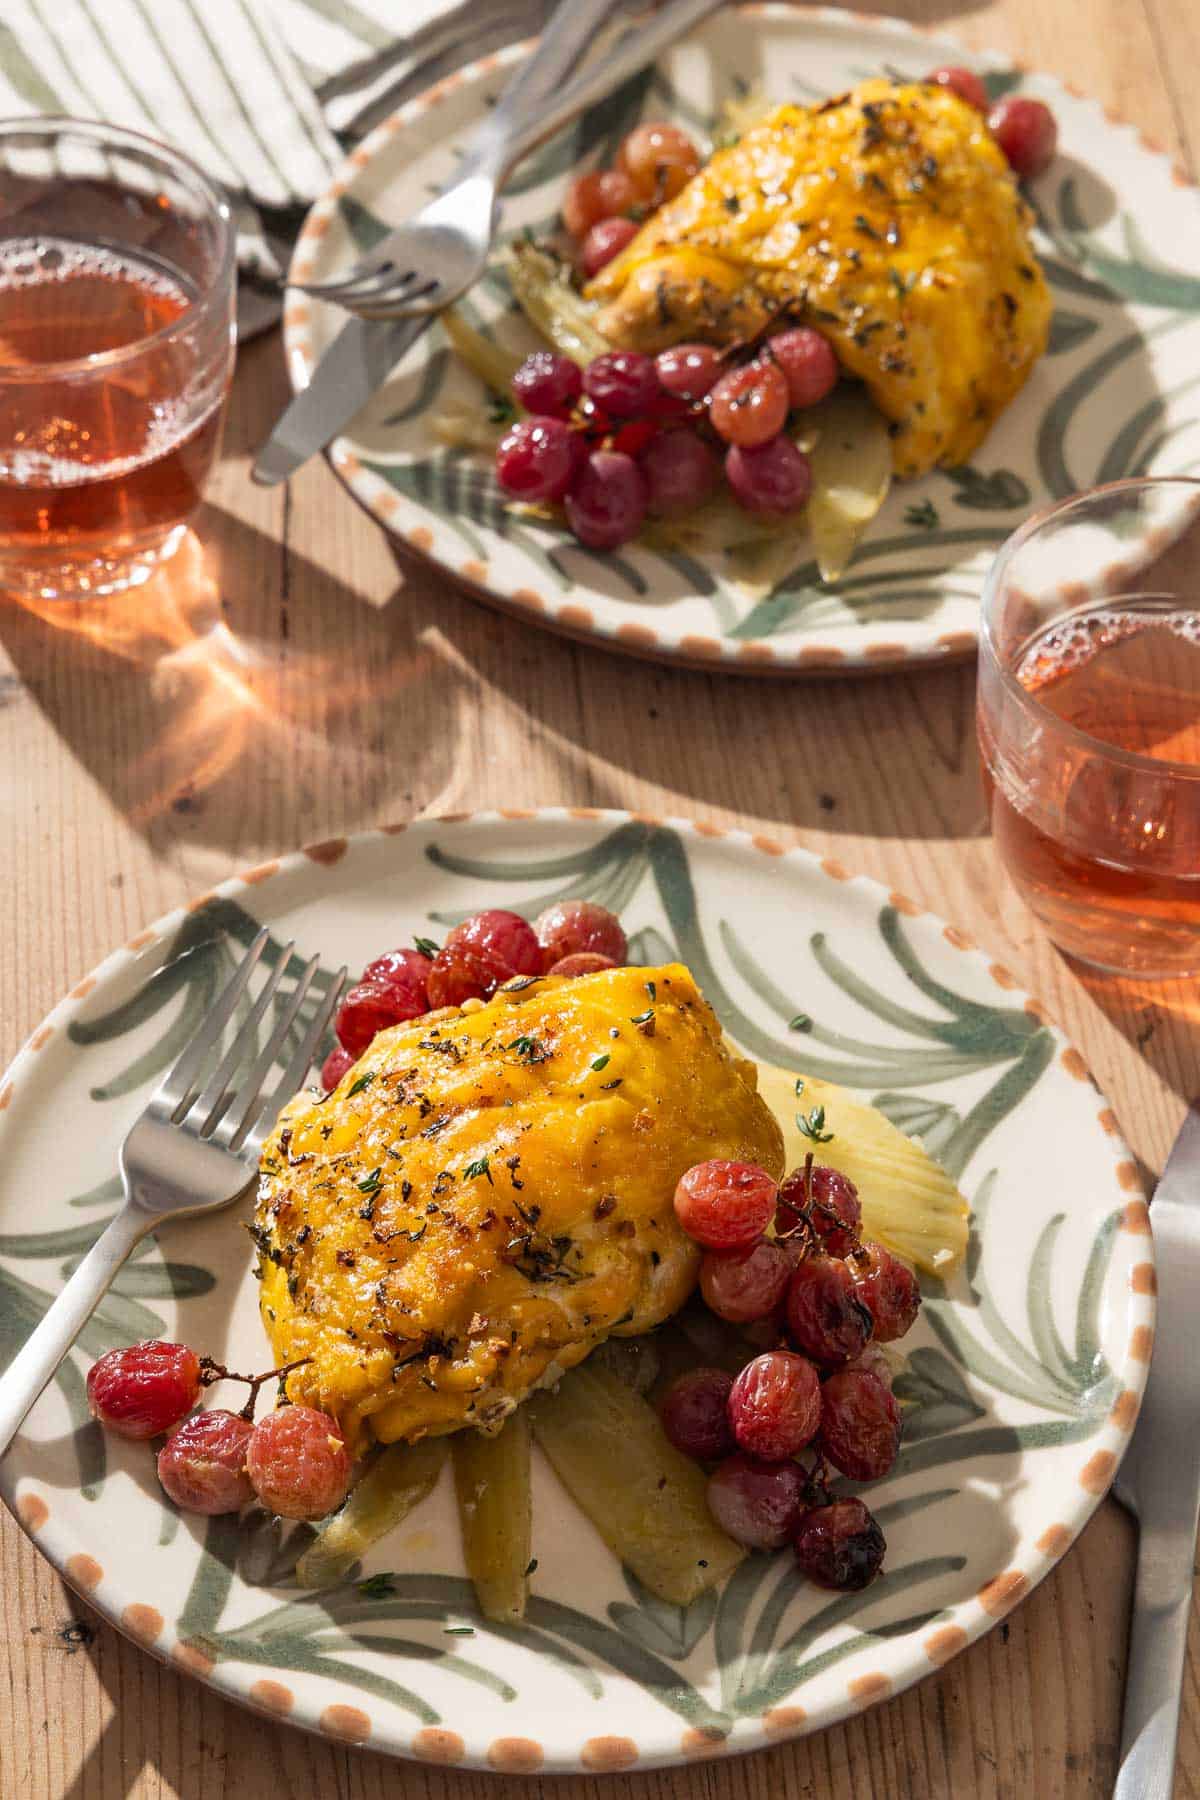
[0,812,1153,1769]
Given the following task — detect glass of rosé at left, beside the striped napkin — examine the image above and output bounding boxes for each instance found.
[0,119,236,599]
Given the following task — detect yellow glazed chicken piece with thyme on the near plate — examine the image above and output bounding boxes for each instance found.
[254,963,783,1447]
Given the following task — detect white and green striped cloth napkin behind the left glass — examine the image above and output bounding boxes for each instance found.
[0,0,551,337]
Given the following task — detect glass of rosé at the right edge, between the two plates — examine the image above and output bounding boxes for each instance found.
[979,477,1200,977]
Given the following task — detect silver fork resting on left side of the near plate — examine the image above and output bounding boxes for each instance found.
[0,931,345,1456]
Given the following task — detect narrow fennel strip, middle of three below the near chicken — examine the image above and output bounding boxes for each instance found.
[452,1408,533,1625]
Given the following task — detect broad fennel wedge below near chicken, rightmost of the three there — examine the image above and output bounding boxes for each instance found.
[525,1363,745,1606]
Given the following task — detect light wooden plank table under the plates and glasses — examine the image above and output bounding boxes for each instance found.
[0,0,1200,1800]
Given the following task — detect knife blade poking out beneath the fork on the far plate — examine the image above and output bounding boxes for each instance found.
[250,313,434,488]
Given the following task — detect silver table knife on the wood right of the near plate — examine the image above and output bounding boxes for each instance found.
[1114,1100,1200,1800]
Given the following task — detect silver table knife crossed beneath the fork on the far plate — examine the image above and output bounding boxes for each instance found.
[250,0,721,488]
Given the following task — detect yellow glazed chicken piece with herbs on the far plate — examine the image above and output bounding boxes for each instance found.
[587,79,1051,475]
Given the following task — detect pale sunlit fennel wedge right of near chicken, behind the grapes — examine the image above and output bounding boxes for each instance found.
[759,1064,970,1276]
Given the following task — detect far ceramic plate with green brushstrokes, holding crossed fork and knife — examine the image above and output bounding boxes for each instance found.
[284,5,1200,673]
